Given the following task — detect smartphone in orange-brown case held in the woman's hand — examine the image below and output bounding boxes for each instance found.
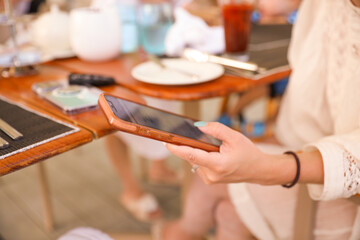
[99,93,221,152]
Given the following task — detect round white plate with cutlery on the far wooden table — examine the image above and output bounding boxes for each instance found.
[131,58,224,85]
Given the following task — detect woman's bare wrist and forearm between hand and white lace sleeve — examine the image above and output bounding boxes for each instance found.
[259,151,324,185]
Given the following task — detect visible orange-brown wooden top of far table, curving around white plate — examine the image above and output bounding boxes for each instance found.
[49,53,290,101]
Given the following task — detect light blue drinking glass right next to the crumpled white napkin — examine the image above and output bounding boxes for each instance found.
[138,2,173,55]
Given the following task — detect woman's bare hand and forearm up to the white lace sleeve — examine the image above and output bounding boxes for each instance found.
[167,123,324,185]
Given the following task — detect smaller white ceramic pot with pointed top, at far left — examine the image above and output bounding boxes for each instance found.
[31,5,71,55]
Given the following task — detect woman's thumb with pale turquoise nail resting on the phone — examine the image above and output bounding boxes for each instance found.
[199,122,239,144]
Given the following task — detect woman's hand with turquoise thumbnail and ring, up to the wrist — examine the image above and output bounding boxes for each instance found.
[166,122,265,184]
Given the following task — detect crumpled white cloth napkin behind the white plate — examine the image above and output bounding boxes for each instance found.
[165,7,225,56]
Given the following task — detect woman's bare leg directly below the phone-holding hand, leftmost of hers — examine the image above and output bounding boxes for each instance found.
[163,176,229,240]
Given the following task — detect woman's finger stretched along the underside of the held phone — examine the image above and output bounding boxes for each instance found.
[166,143,218,167]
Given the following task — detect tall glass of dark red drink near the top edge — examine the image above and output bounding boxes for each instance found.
[222,3,253,53]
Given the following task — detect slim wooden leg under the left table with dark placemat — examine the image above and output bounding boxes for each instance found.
[37,162,54,231]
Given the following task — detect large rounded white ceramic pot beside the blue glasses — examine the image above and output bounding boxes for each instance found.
[70,8,121,61]
